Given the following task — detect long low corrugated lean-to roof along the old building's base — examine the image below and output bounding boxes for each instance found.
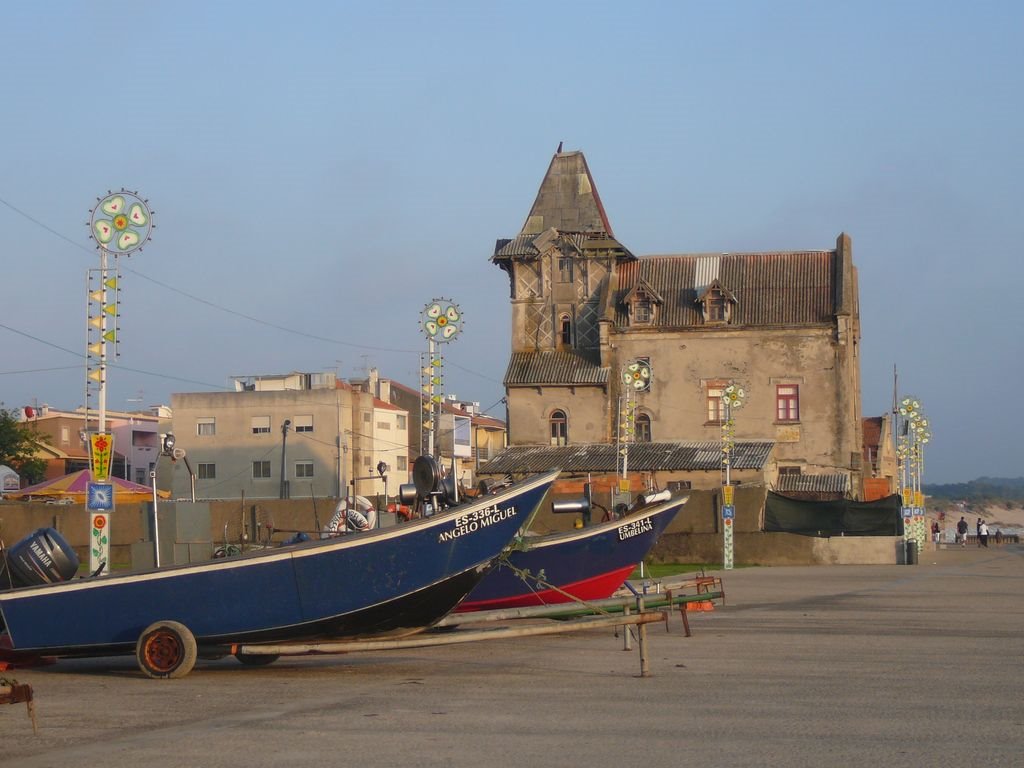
[478,440,775,474]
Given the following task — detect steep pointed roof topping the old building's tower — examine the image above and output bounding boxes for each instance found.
[519,144,614,238]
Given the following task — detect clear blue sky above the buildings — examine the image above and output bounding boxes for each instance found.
[0,0,1024,482]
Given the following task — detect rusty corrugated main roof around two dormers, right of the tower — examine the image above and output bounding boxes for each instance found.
[614,251,836,328]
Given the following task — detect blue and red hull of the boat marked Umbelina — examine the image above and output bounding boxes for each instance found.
[456,498,686,612]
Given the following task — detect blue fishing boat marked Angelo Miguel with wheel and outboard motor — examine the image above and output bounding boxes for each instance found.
[0,469,558,678]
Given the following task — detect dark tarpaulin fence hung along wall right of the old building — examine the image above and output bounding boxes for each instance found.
[765,490,903,537]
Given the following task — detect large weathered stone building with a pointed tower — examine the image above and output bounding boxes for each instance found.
[488,152,862,497]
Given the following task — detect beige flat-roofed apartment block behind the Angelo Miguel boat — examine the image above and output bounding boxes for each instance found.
[171,372,410,499]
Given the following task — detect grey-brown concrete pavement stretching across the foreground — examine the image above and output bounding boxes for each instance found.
[0,546,1024,768]
